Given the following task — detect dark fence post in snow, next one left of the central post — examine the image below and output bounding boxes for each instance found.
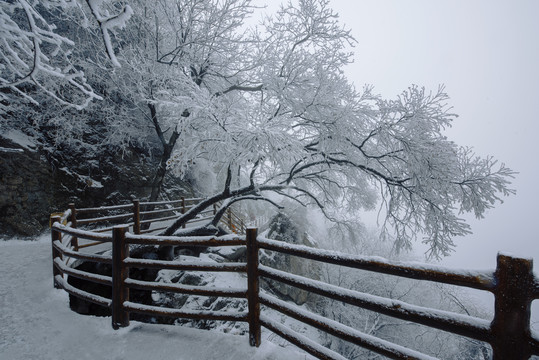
[112,225,129,330]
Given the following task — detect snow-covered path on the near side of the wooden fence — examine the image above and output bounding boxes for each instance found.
[0,237,309,360]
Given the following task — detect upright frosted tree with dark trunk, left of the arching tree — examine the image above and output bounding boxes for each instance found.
[108,0,258,205]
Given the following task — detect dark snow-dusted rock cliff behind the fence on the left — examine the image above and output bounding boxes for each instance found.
[0,134,193,237]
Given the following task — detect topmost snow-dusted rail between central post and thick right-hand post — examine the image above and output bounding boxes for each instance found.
[258,238,495,291]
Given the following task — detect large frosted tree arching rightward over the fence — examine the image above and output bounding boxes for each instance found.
[140,0,513,256]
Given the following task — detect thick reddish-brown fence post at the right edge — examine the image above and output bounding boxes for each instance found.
[491,254,534,360]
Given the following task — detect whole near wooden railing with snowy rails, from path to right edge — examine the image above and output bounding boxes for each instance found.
[51,205,539,360]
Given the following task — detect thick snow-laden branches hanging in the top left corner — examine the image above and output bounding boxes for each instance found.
[0,0,131,114]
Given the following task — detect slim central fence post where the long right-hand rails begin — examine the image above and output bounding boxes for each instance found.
[246,228,261,347]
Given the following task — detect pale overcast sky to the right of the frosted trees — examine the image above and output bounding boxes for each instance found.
[322,0,539,269]
